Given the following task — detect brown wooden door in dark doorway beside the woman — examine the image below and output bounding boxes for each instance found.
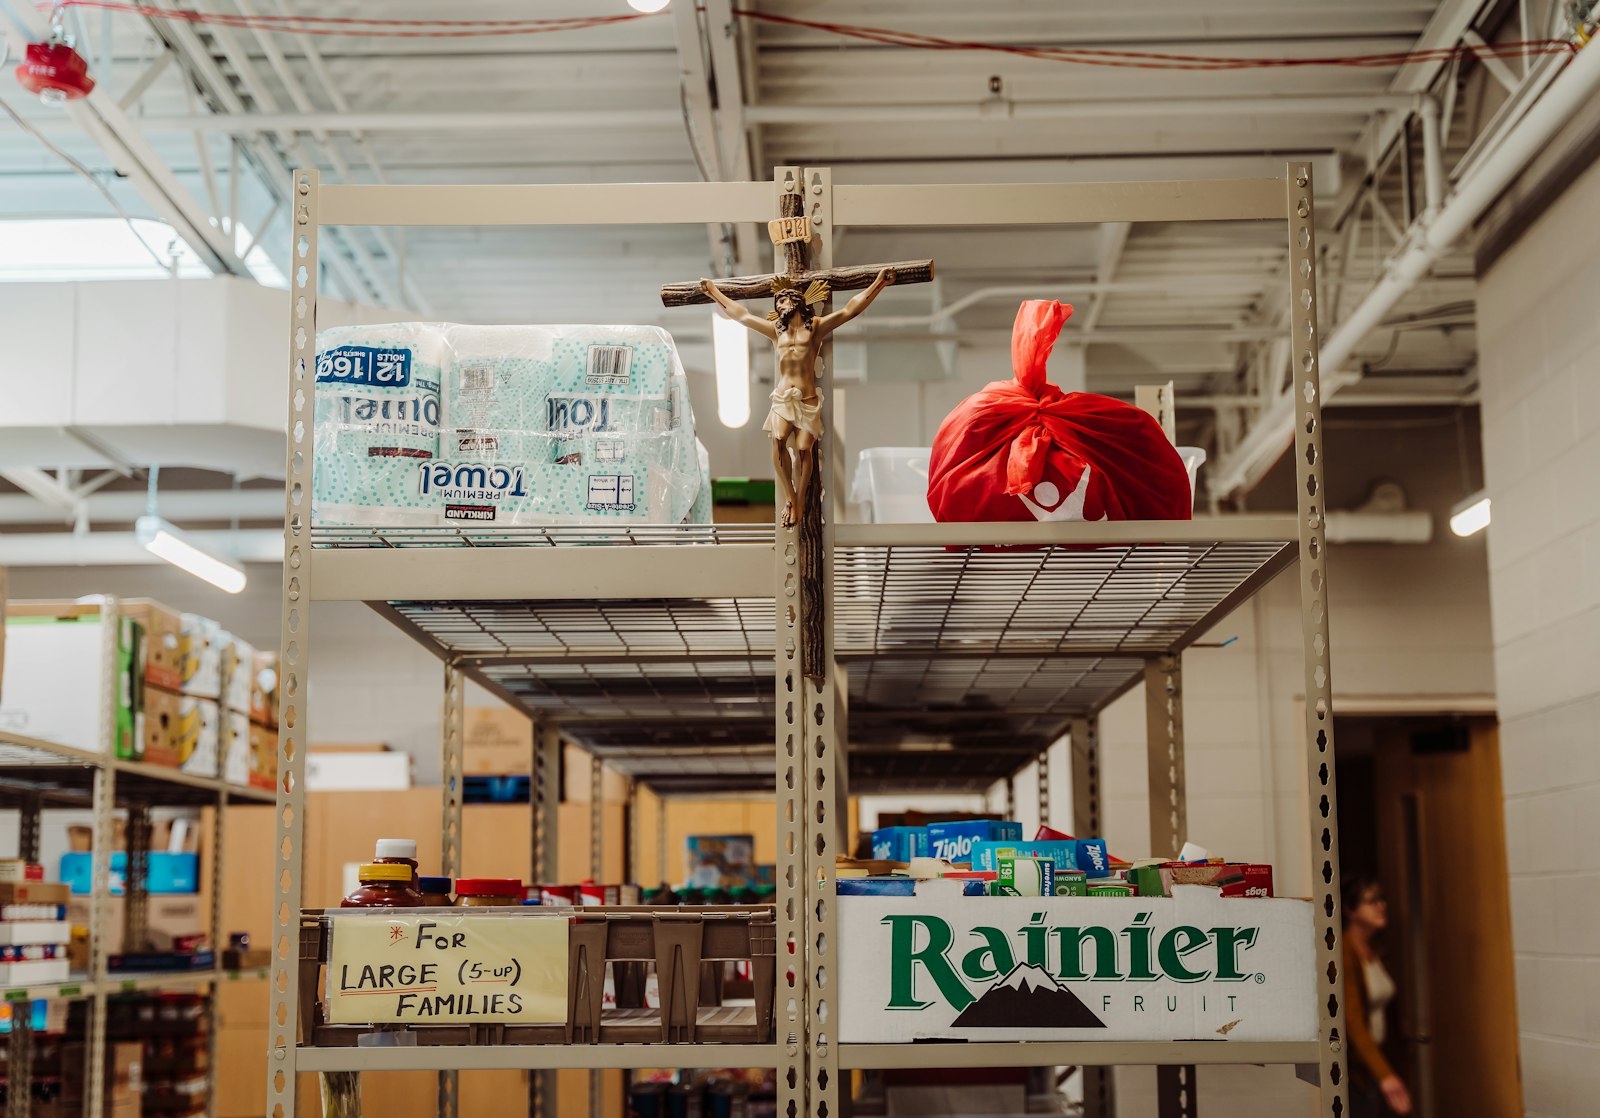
[1374,718,1523,1118]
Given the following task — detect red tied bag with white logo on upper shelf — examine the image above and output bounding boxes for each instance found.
[928,299,1194,521]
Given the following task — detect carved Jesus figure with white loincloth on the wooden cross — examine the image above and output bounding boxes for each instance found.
[699,267,894,528]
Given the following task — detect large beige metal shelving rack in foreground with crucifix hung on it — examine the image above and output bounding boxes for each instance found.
[281,163,1347,1118]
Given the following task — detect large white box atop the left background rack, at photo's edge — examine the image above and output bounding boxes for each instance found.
[0,601,144,760]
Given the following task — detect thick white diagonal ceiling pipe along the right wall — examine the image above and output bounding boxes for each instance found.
[1211,30,1600,496]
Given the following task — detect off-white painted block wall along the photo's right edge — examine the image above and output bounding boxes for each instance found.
[1478,151,1600,1118]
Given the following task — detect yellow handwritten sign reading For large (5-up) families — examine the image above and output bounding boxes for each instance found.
[326,915,566,1025]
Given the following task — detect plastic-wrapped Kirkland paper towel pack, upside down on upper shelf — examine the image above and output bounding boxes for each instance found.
[312,323,709,526]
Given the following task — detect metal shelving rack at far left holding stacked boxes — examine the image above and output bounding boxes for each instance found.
[0,598,274,1118]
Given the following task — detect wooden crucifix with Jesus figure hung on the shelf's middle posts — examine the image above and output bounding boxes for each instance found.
[661,192,933,680]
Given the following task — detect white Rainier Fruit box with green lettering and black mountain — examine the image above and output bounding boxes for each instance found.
[838,886,1317,1044]
